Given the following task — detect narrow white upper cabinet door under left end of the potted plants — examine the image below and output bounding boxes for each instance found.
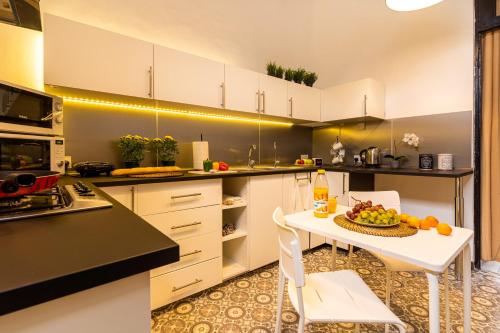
[259,74,288,117]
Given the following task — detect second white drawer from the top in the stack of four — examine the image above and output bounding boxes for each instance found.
[142,205,222,241]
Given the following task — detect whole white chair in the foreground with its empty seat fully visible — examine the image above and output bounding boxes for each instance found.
[273,207,405,333]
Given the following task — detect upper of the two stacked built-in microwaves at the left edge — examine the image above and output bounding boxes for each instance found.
[0,81,63,136]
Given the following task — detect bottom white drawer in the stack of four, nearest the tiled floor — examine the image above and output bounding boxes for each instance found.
[150,257,222,309]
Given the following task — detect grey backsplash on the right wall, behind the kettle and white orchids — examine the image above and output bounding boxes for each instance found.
[313,111,472,168]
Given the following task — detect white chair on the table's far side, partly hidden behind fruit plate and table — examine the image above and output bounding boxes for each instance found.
[349,191,450,332]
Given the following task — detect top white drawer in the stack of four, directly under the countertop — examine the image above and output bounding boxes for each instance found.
[137,179,222,215]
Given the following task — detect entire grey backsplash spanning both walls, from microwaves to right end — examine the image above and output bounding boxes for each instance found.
[47,87,472,167]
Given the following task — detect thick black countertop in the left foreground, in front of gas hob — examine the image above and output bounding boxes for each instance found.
[0,177,179,315]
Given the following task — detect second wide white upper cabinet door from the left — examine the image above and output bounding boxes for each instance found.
[154,45,224,108]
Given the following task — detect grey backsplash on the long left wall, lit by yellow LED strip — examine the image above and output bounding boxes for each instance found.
[47,87,312,167]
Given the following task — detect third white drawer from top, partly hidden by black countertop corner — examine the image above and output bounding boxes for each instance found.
[151,231,222,277]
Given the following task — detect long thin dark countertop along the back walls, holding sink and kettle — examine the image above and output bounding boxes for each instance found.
[78,165,474,187]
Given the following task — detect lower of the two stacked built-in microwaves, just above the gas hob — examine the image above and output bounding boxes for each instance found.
[0,133,65,174]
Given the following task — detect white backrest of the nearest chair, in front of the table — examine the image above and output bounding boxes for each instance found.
[273,207,305,288]
